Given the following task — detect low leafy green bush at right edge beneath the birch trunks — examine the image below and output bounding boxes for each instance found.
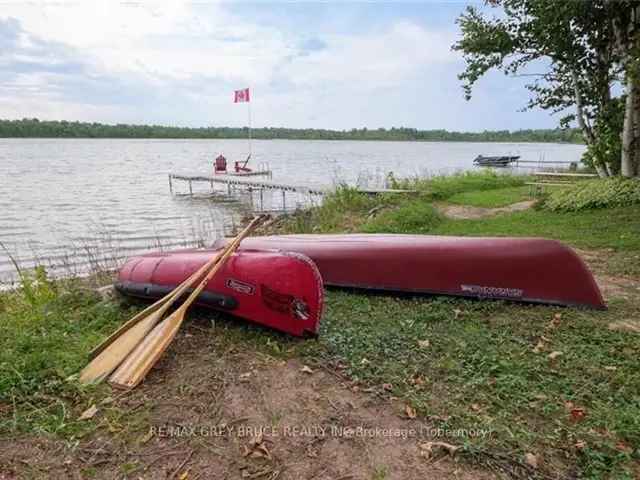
[543,178,640,212]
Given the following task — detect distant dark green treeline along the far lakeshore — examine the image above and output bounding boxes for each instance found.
[0,118,582,143]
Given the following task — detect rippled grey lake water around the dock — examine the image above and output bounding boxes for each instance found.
[0,139,584,282]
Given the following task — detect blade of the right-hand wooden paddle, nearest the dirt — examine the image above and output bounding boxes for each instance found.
[109,307,186,388]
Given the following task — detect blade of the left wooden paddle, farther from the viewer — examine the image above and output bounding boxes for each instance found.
[80,309,165,384]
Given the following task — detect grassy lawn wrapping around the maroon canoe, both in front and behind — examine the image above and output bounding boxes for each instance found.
[270,170,640,478]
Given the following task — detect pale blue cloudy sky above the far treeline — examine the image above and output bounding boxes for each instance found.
[0,0,557,131]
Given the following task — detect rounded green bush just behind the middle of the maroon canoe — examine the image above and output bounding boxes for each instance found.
[361,200,442,233]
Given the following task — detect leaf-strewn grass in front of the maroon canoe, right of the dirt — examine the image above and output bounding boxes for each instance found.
[301,292,640,478]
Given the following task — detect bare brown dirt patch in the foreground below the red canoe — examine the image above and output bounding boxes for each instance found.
[0,322,495,480]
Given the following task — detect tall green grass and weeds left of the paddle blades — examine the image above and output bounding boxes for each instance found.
[0,269,123,432]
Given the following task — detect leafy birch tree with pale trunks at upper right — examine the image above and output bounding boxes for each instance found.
[453,0,640,176]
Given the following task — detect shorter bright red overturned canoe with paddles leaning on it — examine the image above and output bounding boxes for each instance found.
[115,250,323,336]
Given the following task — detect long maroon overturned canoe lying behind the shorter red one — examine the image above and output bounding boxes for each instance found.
[214,234,605,308]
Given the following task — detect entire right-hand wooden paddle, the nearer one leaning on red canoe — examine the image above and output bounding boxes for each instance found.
[109,217,265,388]
